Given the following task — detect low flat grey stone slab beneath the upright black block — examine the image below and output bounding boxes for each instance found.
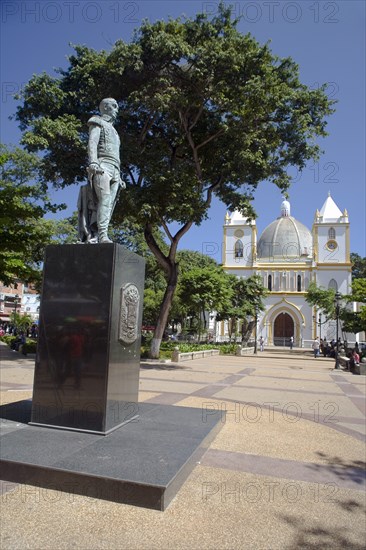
[0,400,224,510]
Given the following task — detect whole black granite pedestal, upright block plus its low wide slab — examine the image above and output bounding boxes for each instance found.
[0,244,223,510]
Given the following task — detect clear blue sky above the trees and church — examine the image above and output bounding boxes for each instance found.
[1,0,366,261]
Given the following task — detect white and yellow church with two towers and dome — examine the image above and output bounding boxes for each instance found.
[216,194,354,347]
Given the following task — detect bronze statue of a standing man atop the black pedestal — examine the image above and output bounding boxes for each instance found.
[84,97,126,243]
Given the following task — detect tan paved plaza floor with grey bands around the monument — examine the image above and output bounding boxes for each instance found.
[0,343,366,550]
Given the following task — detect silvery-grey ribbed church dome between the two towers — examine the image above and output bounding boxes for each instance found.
[257,201,313,261]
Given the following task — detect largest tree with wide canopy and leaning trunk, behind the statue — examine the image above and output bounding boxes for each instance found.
[17,4,332,357]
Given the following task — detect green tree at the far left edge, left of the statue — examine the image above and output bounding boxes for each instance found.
[0,144,62,285]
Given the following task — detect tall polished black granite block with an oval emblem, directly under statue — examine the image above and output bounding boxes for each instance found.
[31,244,145,434]
